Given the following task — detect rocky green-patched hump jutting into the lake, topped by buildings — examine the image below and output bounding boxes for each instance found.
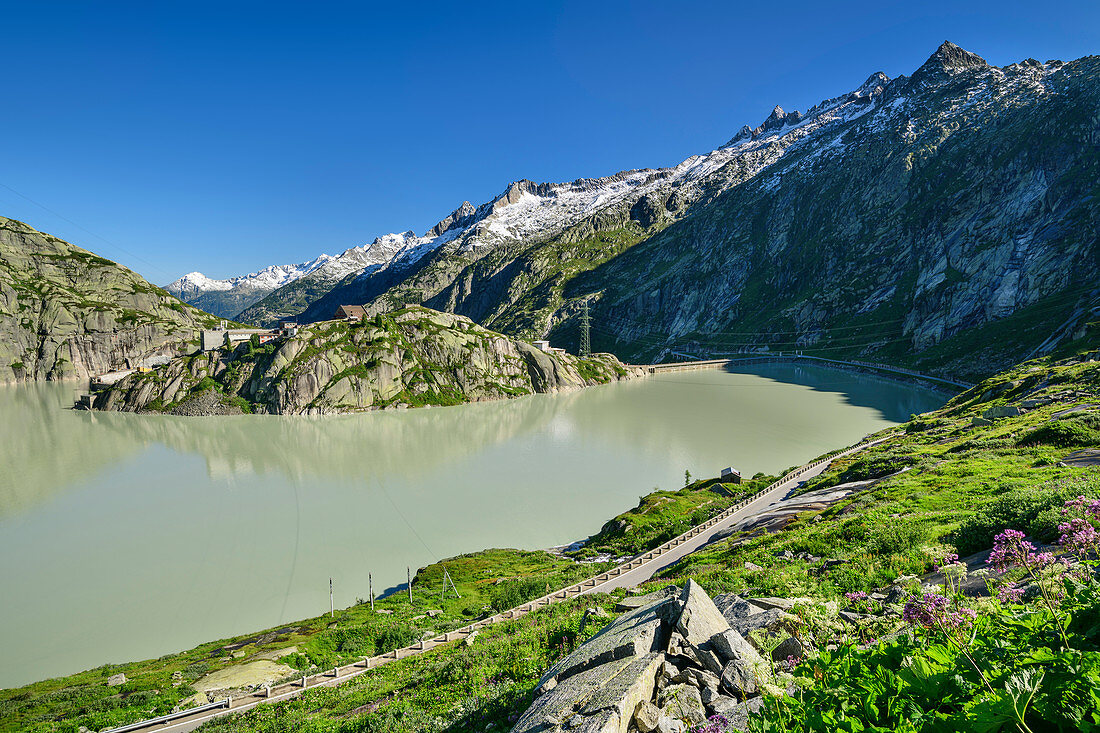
[95,306,641,415]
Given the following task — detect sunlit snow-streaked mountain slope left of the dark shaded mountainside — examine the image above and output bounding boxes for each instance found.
[292,96,866,337]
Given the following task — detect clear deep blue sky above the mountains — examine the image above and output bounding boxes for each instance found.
[0,0,1100,284]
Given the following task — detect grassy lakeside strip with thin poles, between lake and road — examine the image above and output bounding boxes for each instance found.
[0,549,606,732]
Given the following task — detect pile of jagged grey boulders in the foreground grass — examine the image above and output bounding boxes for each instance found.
[513,580,802,733]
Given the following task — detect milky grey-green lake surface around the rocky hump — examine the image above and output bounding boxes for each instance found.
[0,365,946,687]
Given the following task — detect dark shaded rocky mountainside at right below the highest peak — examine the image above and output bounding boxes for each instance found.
[569,44,1100,375]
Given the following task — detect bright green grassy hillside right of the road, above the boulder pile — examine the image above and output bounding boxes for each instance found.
[670,343,1100,598]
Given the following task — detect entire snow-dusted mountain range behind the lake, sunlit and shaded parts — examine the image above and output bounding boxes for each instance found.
[225,43,1100,378]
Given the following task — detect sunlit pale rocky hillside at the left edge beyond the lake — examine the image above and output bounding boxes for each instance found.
[0,217,224,383]
